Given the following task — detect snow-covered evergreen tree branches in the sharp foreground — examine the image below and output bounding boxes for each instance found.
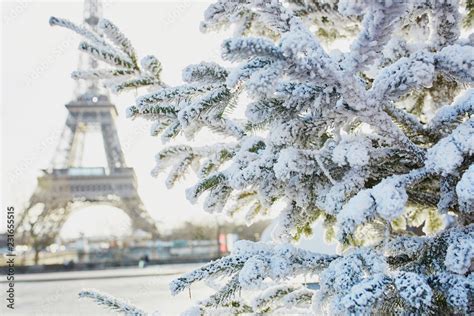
[50,0,474,315]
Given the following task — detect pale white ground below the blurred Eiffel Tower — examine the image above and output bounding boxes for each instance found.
[0,264,212,315]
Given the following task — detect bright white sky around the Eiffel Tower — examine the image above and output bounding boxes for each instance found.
[0,0,233,236]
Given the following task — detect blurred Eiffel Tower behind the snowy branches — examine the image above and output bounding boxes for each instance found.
[17,0,158,261]
